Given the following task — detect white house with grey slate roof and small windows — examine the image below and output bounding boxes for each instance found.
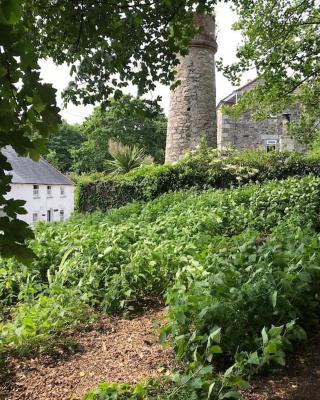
[1,146,74,225]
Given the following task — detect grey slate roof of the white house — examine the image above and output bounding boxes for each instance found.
[1,146,74,185]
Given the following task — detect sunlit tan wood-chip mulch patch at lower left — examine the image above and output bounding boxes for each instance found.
[0,310,175,400]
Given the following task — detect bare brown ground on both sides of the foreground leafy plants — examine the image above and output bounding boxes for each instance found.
[0,310,320,400]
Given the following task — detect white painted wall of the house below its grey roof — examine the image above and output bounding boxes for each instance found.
[5,183,74,225]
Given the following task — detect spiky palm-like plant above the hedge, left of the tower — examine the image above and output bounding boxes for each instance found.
[105,139,153,175]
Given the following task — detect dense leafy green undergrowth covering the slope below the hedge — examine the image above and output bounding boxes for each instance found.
[0,177,320,400]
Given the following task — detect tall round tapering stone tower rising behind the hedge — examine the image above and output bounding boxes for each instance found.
[166,15,217,163]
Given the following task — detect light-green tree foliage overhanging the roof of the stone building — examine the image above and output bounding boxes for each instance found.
[219,0,320,141]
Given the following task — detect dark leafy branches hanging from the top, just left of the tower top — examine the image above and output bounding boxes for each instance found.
[30,0,216,104]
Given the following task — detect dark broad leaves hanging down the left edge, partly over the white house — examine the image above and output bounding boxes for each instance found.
[0,0,59,262]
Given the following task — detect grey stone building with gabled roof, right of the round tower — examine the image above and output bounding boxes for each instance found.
[217,78,303,151]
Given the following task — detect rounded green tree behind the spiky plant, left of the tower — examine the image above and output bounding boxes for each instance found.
[71,95,167,173]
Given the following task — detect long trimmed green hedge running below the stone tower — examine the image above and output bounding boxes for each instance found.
[76,150,320,212]
